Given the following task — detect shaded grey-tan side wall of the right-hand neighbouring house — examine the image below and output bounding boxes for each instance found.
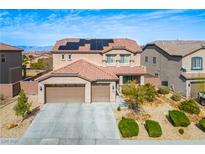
[141,46,186,95]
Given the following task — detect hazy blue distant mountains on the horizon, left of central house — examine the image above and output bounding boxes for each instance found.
[18,45,52,52]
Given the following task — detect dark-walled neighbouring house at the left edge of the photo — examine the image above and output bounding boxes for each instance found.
[0,43,23,97]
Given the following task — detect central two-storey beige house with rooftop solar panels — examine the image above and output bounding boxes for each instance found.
[37,38,159,104]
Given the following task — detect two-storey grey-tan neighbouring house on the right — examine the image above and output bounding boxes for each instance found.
[141,40,205,97]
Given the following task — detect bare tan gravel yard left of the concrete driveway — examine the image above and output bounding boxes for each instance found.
[0,95,40,138]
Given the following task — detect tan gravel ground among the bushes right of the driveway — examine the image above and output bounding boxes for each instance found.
[114,96,205,140]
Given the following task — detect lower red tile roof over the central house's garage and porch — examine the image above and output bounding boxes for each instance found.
[37,59,146,81]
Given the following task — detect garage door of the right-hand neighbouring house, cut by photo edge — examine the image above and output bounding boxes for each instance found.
[191,82,205,98]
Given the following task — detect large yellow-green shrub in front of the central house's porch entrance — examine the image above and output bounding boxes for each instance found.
[121,81,145,110]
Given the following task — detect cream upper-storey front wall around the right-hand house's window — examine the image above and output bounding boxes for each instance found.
[182,49,205,73]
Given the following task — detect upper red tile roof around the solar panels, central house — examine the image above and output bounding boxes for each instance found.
[52,38,142,53]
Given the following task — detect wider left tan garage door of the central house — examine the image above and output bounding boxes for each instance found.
[46,85,85,103]
